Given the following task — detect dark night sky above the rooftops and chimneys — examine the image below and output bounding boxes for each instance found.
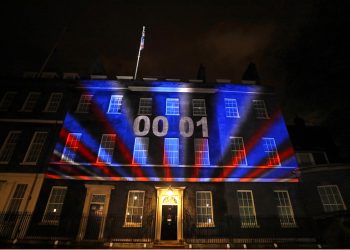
[0,0,350,151]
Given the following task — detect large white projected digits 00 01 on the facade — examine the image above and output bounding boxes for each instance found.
[134,115,208,137]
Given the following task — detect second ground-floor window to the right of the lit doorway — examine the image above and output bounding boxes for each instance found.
[237,190,258,228]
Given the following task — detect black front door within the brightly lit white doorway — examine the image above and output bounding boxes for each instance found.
[160,205,177,240]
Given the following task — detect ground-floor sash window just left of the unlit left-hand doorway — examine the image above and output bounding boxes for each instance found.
[42,186,67,225]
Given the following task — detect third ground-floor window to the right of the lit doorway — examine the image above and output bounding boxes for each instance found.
[274,190,296,227]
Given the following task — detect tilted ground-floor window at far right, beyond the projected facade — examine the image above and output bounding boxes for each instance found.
[317,185,346,212]
